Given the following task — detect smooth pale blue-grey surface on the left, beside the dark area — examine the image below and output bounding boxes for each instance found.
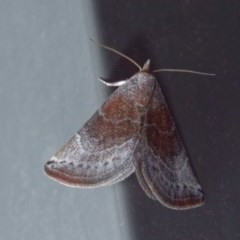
[0,0,131,240]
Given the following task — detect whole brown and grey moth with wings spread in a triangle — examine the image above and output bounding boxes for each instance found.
[44,42,211,210]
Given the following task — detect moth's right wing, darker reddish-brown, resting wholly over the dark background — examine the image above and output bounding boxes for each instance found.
[134,83,204,209]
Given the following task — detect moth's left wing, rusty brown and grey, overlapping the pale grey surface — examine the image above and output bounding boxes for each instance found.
[44,75,155,187]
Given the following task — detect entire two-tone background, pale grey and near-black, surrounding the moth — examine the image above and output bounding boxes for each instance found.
[0,0,240,240]
